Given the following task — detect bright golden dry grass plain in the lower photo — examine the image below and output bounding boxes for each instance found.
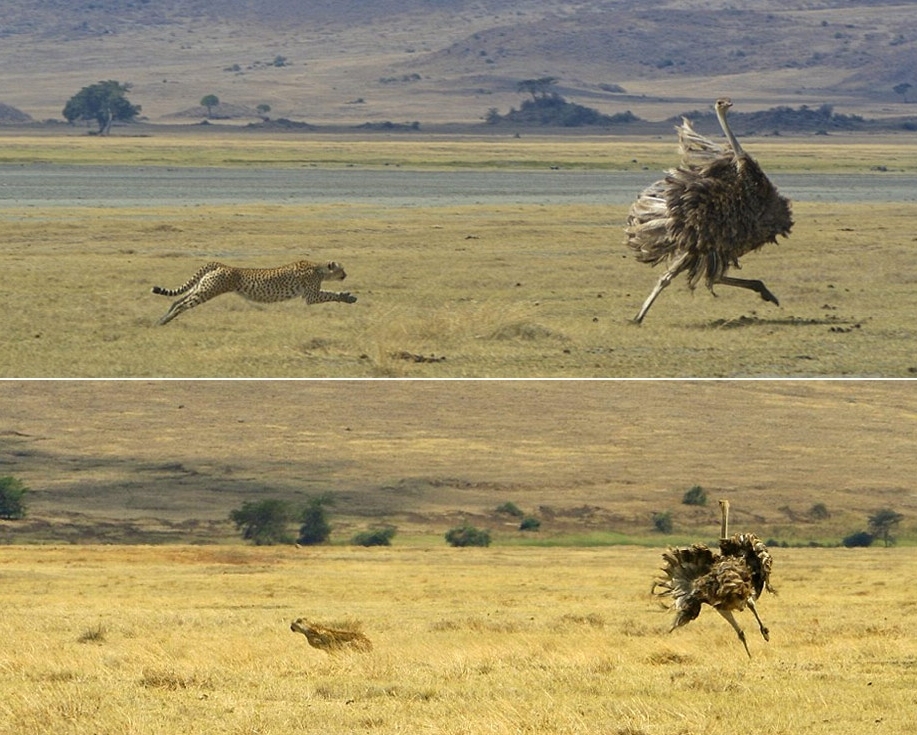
[0,547,917,735]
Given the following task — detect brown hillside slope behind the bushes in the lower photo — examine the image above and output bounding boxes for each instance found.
[0,381,917,545]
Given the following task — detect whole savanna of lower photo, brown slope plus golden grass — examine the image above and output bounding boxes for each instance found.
[0,381,917,735]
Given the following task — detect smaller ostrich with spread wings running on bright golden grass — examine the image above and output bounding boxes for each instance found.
[653,500,774,658]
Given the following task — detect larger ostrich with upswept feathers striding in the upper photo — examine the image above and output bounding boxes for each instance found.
[625,99,793,324]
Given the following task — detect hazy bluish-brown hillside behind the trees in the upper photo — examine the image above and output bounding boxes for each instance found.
[0,0,917,123]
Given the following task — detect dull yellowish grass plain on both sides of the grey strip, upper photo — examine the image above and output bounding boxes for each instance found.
[0,134,917,377]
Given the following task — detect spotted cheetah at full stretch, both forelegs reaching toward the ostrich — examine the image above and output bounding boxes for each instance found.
[153,260,357,325]
